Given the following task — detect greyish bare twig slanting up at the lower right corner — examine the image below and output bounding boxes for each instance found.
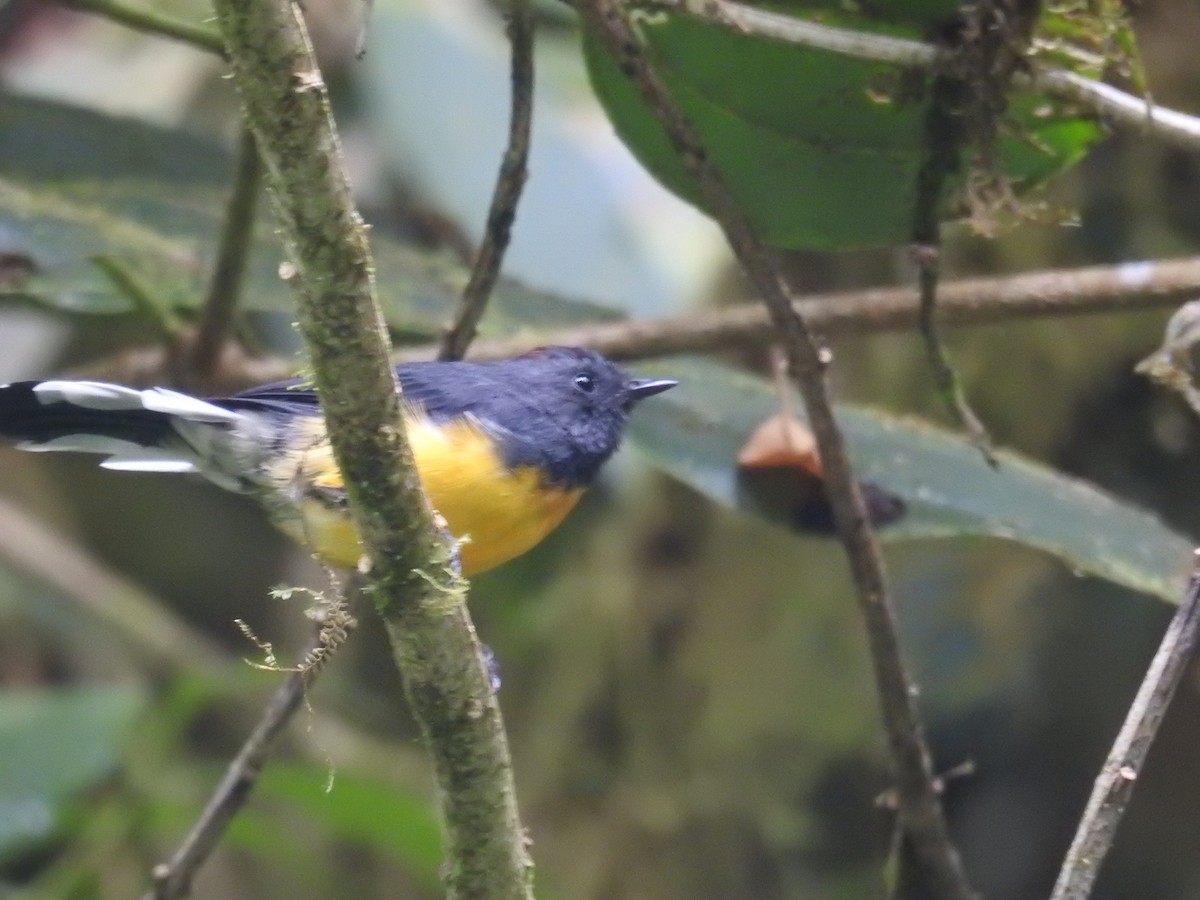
[1051,551,1200,900]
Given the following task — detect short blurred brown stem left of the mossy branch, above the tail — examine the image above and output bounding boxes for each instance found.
[186,128,263,385]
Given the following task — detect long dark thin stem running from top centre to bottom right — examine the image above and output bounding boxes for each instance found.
[580,0,972,900]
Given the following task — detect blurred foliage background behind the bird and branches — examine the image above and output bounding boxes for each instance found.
[0,0,1200,900]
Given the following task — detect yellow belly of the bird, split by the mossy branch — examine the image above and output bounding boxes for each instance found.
[274,419,583,575]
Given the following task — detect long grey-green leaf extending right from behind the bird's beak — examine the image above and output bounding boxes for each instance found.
[630,360,1192,602]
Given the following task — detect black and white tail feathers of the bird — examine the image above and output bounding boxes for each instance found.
[0,382,241,472]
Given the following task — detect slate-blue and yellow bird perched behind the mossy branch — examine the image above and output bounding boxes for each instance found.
[0,347,677,576]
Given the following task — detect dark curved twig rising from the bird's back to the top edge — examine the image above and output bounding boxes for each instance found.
[438,0,534,360]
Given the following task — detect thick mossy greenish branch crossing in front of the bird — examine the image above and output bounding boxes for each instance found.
[215,0,530,898]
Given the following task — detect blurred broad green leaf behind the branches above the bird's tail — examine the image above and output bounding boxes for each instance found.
[0,94,617,337]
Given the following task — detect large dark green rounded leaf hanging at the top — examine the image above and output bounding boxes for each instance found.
[584,10,1100,250]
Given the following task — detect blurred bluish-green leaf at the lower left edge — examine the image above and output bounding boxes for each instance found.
[0,686,145,856]
